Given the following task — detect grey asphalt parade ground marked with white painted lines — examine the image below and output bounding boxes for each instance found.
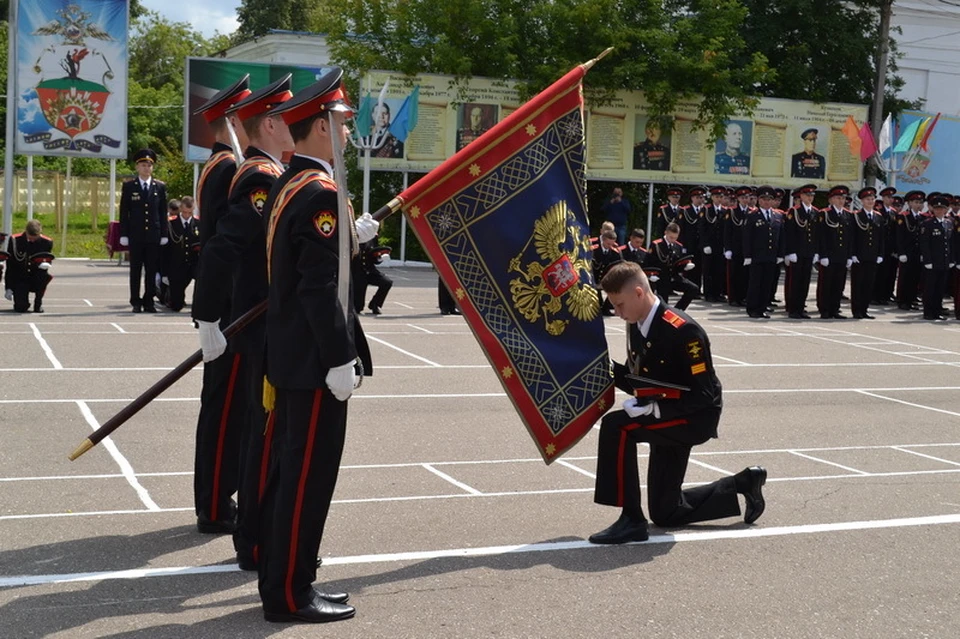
[0,260,960,639]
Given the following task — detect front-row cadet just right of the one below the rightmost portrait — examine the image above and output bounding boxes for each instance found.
[817,185,853,319]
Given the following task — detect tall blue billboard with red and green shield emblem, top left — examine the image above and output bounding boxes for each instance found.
[13,0,128,158]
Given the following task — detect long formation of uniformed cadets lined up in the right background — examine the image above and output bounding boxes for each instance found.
[594,184,960,320]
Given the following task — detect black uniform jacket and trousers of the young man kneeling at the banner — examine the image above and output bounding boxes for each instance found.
[594,303,740,527]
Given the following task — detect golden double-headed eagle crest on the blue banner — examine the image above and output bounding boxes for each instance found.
[509,201,600,335]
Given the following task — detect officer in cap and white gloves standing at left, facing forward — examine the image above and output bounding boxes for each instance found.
[120,149,169,313]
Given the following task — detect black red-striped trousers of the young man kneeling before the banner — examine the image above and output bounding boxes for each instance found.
[593,410,740,527]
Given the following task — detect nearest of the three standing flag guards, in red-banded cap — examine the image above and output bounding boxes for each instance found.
[259,67,379,623]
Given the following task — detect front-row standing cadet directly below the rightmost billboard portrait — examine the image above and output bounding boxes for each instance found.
[783,184,820,319]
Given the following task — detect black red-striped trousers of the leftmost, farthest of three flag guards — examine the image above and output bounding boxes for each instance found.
[193,352,245,520]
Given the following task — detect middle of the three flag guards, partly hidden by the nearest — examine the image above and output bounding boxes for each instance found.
[193,74,293,570]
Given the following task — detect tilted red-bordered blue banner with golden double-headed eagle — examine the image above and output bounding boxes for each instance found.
[399,66,613,464]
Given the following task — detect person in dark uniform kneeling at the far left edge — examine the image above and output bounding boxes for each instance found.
[0,220,53,313]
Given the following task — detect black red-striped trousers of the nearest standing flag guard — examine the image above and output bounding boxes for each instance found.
[258,388,347,612]
